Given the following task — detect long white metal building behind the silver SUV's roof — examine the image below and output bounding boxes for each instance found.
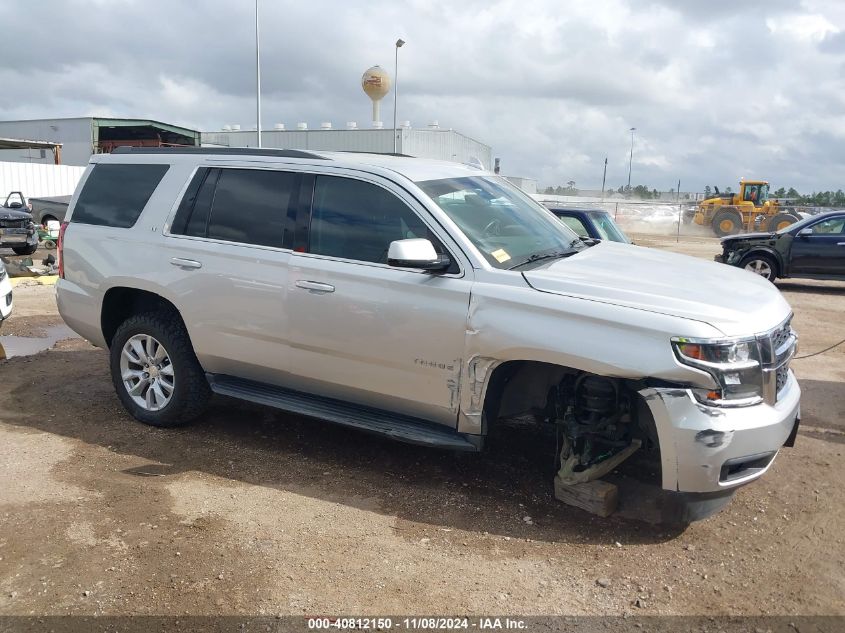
[202,127,493,169]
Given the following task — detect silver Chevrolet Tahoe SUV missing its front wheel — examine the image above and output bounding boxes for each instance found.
[57,148,800,518]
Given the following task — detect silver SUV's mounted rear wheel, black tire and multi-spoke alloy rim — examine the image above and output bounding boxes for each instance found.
[109,311,211,427]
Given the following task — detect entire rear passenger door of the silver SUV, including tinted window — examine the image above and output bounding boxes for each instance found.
[165,167,302,384]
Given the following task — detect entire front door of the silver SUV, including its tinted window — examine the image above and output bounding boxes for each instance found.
[287,175,472,427]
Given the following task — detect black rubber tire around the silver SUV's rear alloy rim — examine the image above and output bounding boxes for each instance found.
[109,310,211,427]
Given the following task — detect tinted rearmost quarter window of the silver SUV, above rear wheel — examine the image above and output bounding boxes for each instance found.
[71,164,170,229]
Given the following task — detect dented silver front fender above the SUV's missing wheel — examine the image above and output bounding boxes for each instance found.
[458,282,722,434]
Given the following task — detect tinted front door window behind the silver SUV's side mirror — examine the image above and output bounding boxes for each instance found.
[309,176,442,263]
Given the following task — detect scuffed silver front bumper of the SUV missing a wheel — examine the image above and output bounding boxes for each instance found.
[639,370,801,493]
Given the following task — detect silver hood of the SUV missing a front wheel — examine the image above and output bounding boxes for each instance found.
[523,242,791,336]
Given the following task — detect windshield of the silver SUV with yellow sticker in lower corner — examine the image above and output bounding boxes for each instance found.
[417,176,586,269]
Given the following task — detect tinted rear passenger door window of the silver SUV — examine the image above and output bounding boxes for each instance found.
[172,169,299,248]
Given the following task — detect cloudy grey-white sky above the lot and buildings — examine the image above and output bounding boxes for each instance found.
[0,0,845,192]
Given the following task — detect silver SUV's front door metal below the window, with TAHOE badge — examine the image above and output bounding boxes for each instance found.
[287,253,471,426]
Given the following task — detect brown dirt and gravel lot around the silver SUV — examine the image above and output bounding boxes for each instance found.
[0,236,845,615]
